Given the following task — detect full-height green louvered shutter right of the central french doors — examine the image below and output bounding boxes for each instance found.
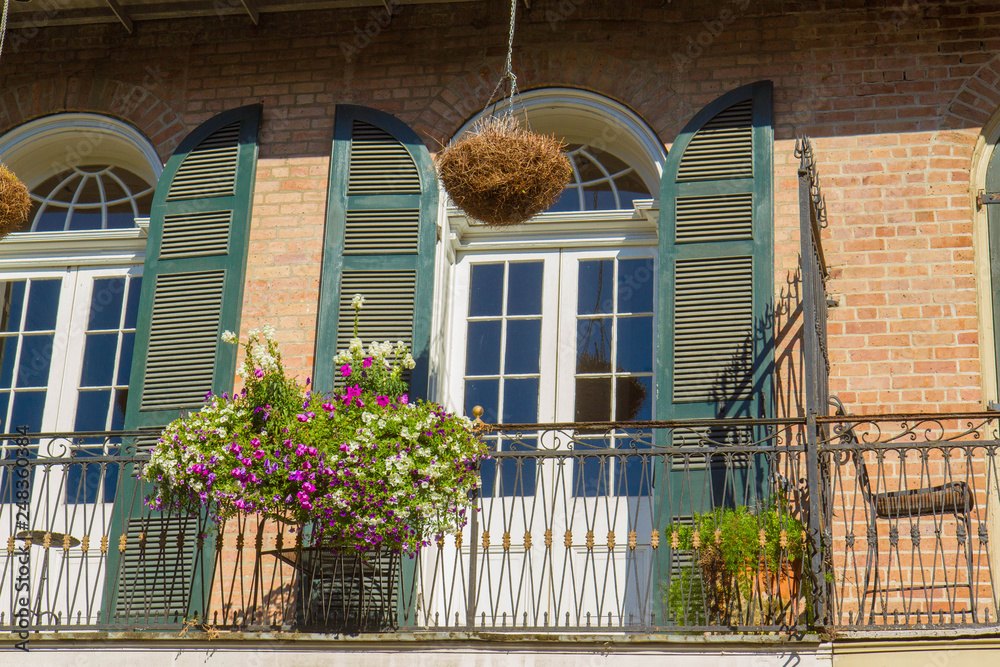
[656,81,774,625]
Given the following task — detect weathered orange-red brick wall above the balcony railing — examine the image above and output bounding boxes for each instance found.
[0,0,1000,413]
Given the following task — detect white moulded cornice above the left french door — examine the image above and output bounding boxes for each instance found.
[0,220,149,269]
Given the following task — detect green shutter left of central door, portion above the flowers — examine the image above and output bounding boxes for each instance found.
[313,105,438,397]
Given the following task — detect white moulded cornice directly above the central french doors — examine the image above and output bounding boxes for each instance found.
[446,199,659,253]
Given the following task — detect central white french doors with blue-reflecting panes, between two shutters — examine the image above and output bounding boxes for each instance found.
[425,249,656,627]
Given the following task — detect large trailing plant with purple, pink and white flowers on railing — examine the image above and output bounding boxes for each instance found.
[143,295,486,553]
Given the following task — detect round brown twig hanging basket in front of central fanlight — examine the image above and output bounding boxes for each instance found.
[437,115,572,227]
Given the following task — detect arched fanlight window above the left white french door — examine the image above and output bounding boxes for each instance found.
[28,165,153,232]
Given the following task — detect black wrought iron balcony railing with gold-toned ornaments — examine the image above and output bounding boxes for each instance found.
[0,414,1000,632]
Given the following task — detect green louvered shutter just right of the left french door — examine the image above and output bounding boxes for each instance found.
[104,105,261,625]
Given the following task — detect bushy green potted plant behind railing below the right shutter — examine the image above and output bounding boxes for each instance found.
[664,496,809,625]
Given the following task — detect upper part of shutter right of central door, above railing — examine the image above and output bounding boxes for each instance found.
[656,81,774,419]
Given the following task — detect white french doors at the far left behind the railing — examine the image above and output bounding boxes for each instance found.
[0,267,141,623]
